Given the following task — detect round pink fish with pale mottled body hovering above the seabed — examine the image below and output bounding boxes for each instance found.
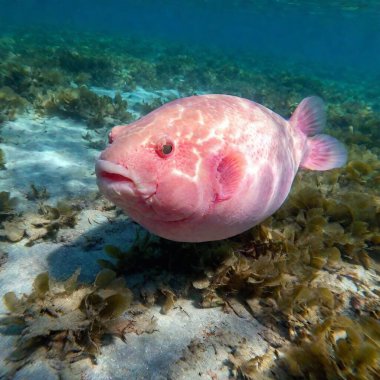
[96,95,347,242]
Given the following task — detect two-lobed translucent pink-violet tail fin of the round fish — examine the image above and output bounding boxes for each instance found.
[289,96,347,170]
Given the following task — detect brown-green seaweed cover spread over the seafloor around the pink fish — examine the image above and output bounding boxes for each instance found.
[0,30,380,379]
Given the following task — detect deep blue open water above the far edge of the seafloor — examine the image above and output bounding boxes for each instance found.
[0,0,380,77]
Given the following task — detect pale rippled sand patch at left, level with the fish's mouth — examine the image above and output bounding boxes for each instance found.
[0,114,98,208]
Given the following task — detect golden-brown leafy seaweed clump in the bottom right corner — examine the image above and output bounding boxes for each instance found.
[283,316,380,379]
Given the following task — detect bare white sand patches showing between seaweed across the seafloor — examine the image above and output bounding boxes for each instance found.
[0,88,378,380]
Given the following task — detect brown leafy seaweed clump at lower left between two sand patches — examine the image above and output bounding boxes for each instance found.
[0,269,154,375]
